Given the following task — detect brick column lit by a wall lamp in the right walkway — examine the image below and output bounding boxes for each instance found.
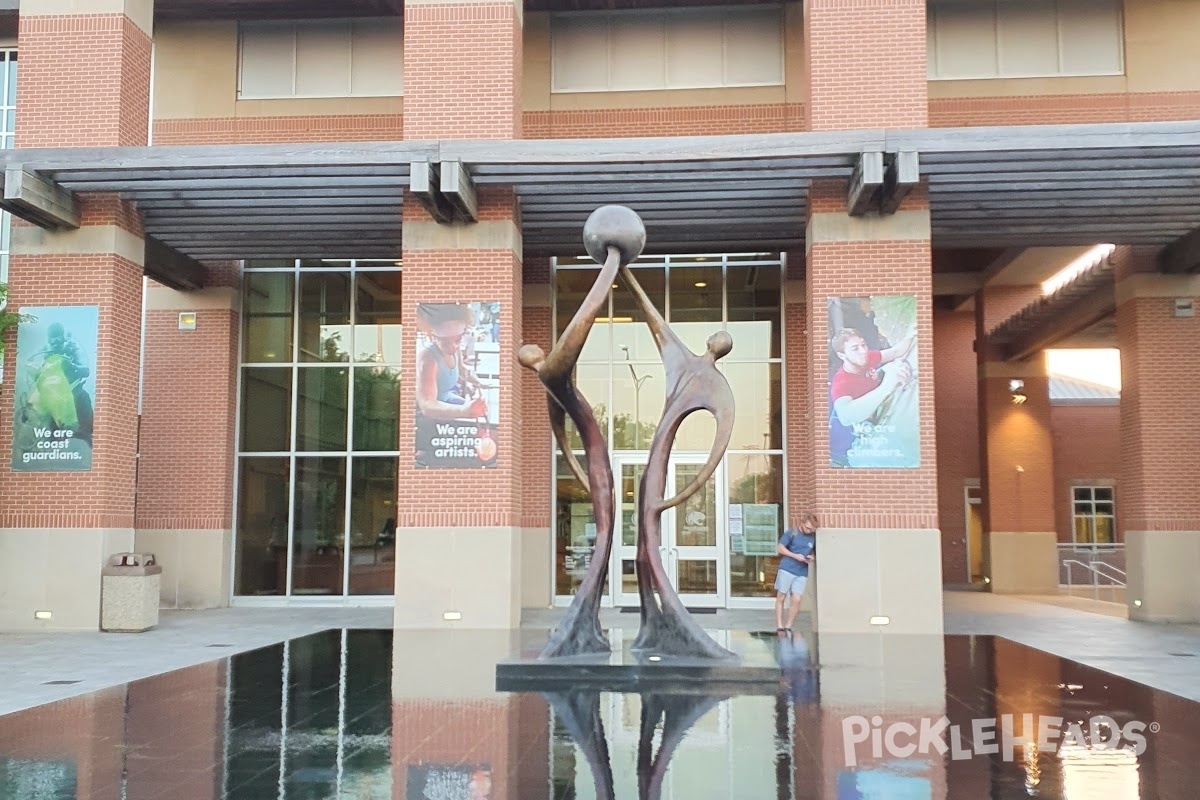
[976,287,1058,595]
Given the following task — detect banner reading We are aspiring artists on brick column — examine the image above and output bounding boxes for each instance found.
[414,302,500,469]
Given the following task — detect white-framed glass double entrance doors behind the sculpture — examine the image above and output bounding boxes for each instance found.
[611,455,728,608]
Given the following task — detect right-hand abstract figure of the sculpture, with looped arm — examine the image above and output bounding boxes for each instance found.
[620,266,737,660]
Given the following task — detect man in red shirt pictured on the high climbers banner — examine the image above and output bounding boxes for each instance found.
[829,327,917,467]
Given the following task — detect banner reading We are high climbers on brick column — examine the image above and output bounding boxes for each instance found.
[828,295,920,469]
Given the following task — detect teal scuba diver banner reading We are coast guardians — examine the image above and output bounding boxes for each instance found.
[12,306,100,473]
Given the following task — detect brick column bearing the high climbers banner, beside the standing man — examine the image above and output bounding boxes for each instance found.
[793,0,942,634]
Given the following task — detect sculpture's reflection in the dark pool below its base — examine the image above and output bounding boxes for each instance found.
[542,690,732,800]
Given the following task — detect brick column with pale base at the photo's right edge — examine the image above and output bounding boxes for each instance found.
[1116,248,1200,622]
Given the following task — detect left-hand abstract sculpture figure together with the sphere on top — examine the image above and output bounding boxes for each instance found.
[517,206,646,658]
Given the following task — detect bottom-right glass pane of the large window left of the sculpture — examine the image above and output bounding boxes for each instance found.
[350,458,397,595]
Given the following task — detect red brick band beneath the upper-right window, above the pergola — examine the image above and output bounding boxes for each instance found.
[929,91,1200,127]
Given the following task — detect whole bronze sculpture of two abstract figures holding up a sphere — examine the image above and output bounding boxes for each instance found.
[517,205,737,661]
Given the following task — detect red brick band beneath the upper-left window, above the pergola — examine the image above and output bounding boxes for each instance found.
[154,114,403,144]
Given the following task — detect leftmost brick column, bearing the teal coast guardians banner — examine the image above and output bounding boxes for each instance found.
[0,0,154,630]
